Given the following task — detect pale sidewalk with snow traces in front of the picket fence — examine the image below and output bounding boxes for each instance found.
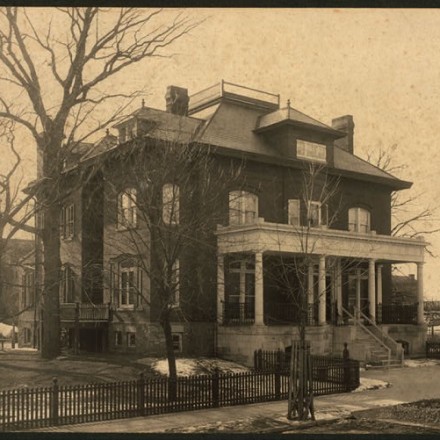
[28,365,440,433]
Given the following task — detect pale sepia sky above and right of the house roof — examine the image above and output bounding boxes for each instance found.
[2,8,440,300]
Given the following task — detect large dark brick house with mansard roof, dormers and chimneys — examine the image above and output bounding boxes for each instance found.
[24,82,426,363]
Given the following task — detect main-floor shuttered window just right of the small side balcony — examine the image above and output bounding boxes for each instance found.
[110,255,142,310]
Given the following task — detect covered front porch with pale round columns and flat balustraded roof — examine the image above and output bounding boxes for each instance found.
[217,219,425,364]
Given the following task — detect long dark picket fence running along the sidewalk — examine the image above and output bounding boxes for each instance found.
[0,355,359,431]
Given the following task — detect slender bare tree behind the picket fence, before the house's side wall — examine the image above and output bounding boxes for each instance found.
[98,137,240,399]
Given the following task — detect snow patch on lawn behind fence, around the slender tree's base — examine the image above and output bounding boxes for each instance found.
[151,358,250,376]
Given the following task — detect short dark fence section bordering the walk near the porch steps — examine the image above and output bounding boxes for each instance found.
[254,350,360,396]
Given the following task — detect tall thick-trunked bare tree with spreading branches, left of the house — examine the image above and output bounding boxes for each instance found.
[0,7,198,358]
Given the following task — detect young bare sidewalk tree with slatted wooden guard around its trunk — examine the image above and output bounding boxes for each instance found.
[265,163,341,420]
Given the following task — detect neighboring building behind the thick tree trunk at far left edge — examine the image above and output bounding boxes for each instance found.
[0,239,37,346]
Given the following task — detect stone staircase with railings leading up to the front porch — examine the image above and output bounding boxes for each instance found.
[343,309,403,368]
